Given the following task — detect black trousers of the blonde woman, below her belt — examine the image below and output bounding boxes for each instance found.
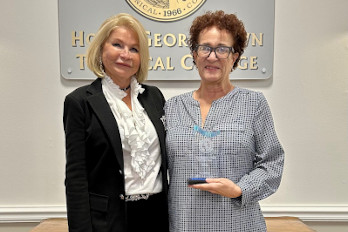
[126,193,169,232]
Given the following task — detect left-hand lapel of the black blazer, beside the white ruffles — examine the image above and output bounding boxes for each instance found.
[87,78,124,171]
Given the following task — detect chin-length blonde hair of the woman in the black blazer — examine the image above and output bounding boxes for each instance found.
[87,13,150,83]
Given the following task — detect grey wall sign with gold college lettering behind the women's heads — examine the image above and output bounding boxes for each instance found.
[58,0,274,80]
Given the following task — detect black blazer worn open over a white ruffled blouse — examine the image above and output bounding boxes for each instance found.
[63,78,168,232]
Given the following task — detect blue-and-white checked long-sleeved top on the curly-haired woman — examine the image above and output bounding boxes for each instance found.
[165,87,284,232]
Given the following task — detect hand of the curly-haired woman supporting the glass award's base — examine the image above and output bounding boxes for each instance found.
[189,178,242,198]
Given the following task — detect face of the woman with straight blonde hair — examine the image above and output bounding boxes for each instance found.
[102,26,140,83]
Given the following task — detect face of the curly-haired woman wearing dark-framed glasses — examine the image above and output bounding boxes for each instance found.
[193,26,238,83]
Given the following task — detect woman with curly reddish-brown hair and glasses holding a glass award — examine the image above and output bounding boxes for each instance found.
[165,11,284,232]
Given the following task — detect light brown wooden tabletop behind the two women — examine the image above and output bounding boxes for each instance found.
[31,217,314,232]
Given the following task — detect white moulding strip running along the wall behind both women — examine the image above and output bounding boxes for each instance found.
[0,205,348,223]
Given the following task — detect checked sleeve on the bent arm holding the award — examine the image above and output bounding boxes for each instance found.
[237,93,284,205]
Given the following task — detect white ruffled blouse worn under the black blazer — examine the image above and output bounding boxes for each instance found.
[102,76,162,195]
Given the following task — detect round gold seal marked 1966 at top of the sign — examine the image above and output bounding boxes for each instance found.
[126,0,206,22]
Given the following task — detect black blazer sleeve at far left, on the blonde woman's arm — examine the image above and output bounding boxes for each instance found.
[63,95,92,232]
